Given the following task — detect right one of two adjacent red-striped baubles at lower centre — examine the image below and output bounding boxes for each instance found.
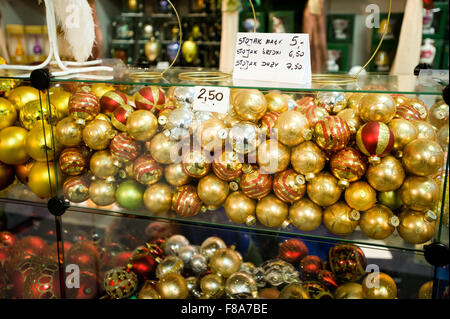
[272,169,306,204]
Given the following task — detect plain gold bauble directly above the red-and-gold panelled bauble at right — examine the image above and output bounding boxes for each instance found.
[359,93,396,124]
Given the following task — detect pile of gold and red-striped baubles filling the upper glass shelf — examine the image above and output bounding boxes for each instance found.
[0,83,449,244]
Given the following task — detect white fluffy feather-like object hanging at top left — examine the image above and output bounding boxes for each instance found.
[52,0,95,62]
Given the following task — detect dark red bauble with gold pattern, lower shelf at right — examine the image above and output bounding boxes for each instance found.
[328,244,367,282]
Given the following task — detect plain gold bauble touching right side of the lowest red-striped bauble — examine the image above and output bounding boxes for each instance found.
[197,174,230,208]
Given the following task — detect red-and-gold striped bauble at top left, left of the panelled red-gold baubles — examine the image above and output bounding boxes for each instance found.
[68,91,100,125]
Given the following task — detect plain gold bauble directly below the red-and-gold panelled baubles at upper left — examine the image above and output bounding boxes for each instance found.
[127,110,158,141]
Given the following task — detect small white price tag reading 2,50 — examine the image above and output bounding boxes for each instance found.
[193,86,230,114]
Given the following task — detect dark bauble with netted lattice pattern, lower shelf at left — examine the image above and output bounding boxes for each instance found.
[103,267,138,299]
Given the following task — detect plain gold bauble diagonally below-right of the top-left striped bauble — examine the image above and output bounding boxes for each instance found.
[83,119,117,150]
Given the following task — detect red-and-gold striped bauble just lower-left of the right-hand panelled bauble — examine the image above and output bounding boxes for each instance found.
[330,147,367,188]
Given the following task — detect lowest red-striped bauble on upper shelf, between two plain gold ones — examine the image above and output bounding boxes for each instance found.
[172,185,203,217]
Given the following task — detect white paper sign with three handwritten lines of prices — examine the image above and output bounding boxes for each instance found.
[233,32,311,84]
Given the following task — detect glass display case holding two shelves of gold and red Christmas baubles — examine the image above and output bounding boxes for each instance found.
[0,68,449,299]
